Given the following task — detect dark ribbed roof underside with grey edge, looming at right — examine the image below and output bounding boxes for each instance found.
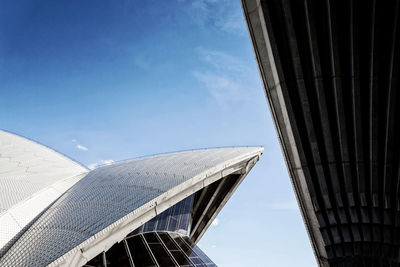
[242,0,400,266]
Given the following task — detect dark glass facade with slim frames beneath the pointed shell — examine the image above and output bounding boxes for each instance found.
[86,195,216,267]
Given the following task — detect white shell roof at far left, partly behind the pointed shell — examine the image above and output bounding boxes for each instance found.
[0,130,88,248]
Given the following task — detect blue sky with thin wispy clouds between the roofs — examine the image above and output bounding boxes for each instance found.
[0,0,316,267]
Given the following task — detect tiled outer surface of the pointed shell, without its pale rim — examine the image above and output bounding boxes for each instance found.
[0,148,261,266]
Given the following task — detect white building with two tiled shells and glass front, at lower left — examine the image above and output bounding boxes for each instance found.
[0,131,263,267]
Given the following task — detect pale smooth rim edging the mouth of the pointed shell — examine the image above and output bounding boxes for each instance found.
[48,147,264,266]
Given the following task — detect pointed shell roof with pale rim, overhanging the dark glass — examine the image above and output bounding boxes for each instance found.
[0,148,262,266]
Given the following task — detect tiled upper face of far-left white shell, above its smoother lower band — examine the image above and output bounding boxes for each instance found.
[0,130,87,214]
